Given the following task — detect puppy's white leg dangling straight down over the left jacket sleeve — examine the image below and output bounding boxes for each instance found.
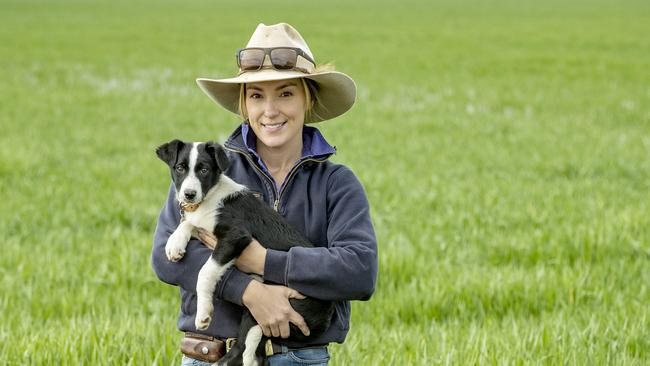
[194,256,235,330]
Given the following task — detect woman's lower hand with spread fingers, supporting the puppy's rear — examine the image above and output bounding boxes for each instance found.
[242,280,309,338]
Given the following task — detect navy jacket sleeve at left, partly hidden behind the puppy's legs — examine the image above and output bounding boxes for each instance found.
[151,185,251,305]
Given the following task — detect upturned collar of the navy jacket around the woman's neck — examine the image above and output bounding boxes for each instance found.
[224,122,336,161]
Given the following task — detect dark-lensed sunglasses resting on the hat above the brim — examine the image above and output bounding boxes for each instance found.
[237,47,315,73]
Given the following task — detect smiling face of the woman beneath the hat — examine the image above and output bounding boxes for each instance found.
[246,79,305,148]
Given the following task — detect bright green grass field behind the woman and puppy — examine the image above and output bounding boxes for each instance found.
[0,0,650,365]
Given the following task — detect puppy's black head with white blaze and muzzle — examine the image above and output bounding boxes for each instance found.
[156,140,229,205]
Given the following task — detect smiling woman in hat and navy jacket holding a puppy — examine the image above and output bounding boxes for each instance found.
[152,24,377,365]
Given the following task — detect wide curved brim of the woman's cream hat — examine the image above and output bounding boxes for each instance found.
[196,69,357,123]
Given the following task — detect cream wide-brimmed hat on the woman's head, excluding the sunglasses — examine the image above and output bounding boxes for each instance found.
[196,23,357,123]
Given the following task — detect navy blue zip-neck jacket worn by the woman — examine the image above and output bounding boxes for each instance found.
[152,124,377,347]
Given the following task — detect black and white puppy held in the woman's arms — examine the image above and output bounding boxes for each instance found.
[156,140,334,366]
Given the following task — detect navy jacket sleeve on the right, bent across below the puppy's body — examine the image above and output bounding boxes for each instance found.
[264,167,378,300]
